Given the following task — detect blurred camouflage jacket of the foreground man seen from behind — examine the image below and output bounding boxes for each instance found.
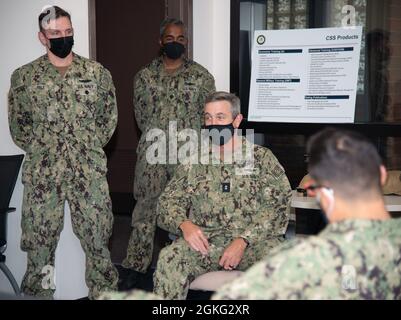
[213,219,401,300]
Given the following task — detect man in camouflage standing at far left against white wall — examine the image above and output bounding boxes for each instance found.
[9,6,118,298]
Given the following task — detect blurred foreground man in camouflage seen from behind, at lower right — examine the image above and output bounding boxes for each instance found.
[214,129,401,300]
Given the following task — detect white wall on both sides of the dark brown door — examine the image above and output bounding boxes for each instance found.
[0,0,255,299]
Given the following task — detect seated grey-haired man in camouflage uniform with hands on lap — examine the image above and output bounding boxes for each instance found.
[154,92,291,299]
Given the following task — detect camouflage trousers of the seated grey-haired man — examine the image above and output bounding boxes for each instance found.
[153,238,283,300]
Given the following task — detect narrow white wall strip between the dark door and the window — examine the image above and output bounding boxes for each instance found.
[193,0,230,91]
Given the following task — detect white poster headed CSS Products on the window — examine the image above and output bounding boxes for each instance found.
[248,27,362,123]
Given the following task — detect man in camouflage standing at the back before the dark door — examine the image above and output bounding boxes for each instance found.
[122,19,215,273]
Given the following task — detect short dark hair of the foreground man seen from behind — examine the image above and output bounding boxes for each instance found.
[307,128,382,200]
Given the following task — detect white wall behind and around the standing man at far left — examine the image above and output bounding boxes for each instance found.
[0,0,89,299]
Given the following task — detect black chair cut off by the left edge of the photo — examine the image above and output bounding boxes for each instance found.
[0,154,24,296]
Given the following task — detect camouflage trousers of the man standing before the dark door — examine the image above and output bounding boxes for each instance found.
[122,152,175,273]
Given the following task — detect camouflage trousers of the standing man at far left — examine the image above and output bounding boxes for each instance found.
[21,177,118,299]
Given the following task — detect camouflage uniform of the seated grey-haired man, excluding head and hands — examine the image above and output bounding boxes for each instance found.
[154,138,291,299]
